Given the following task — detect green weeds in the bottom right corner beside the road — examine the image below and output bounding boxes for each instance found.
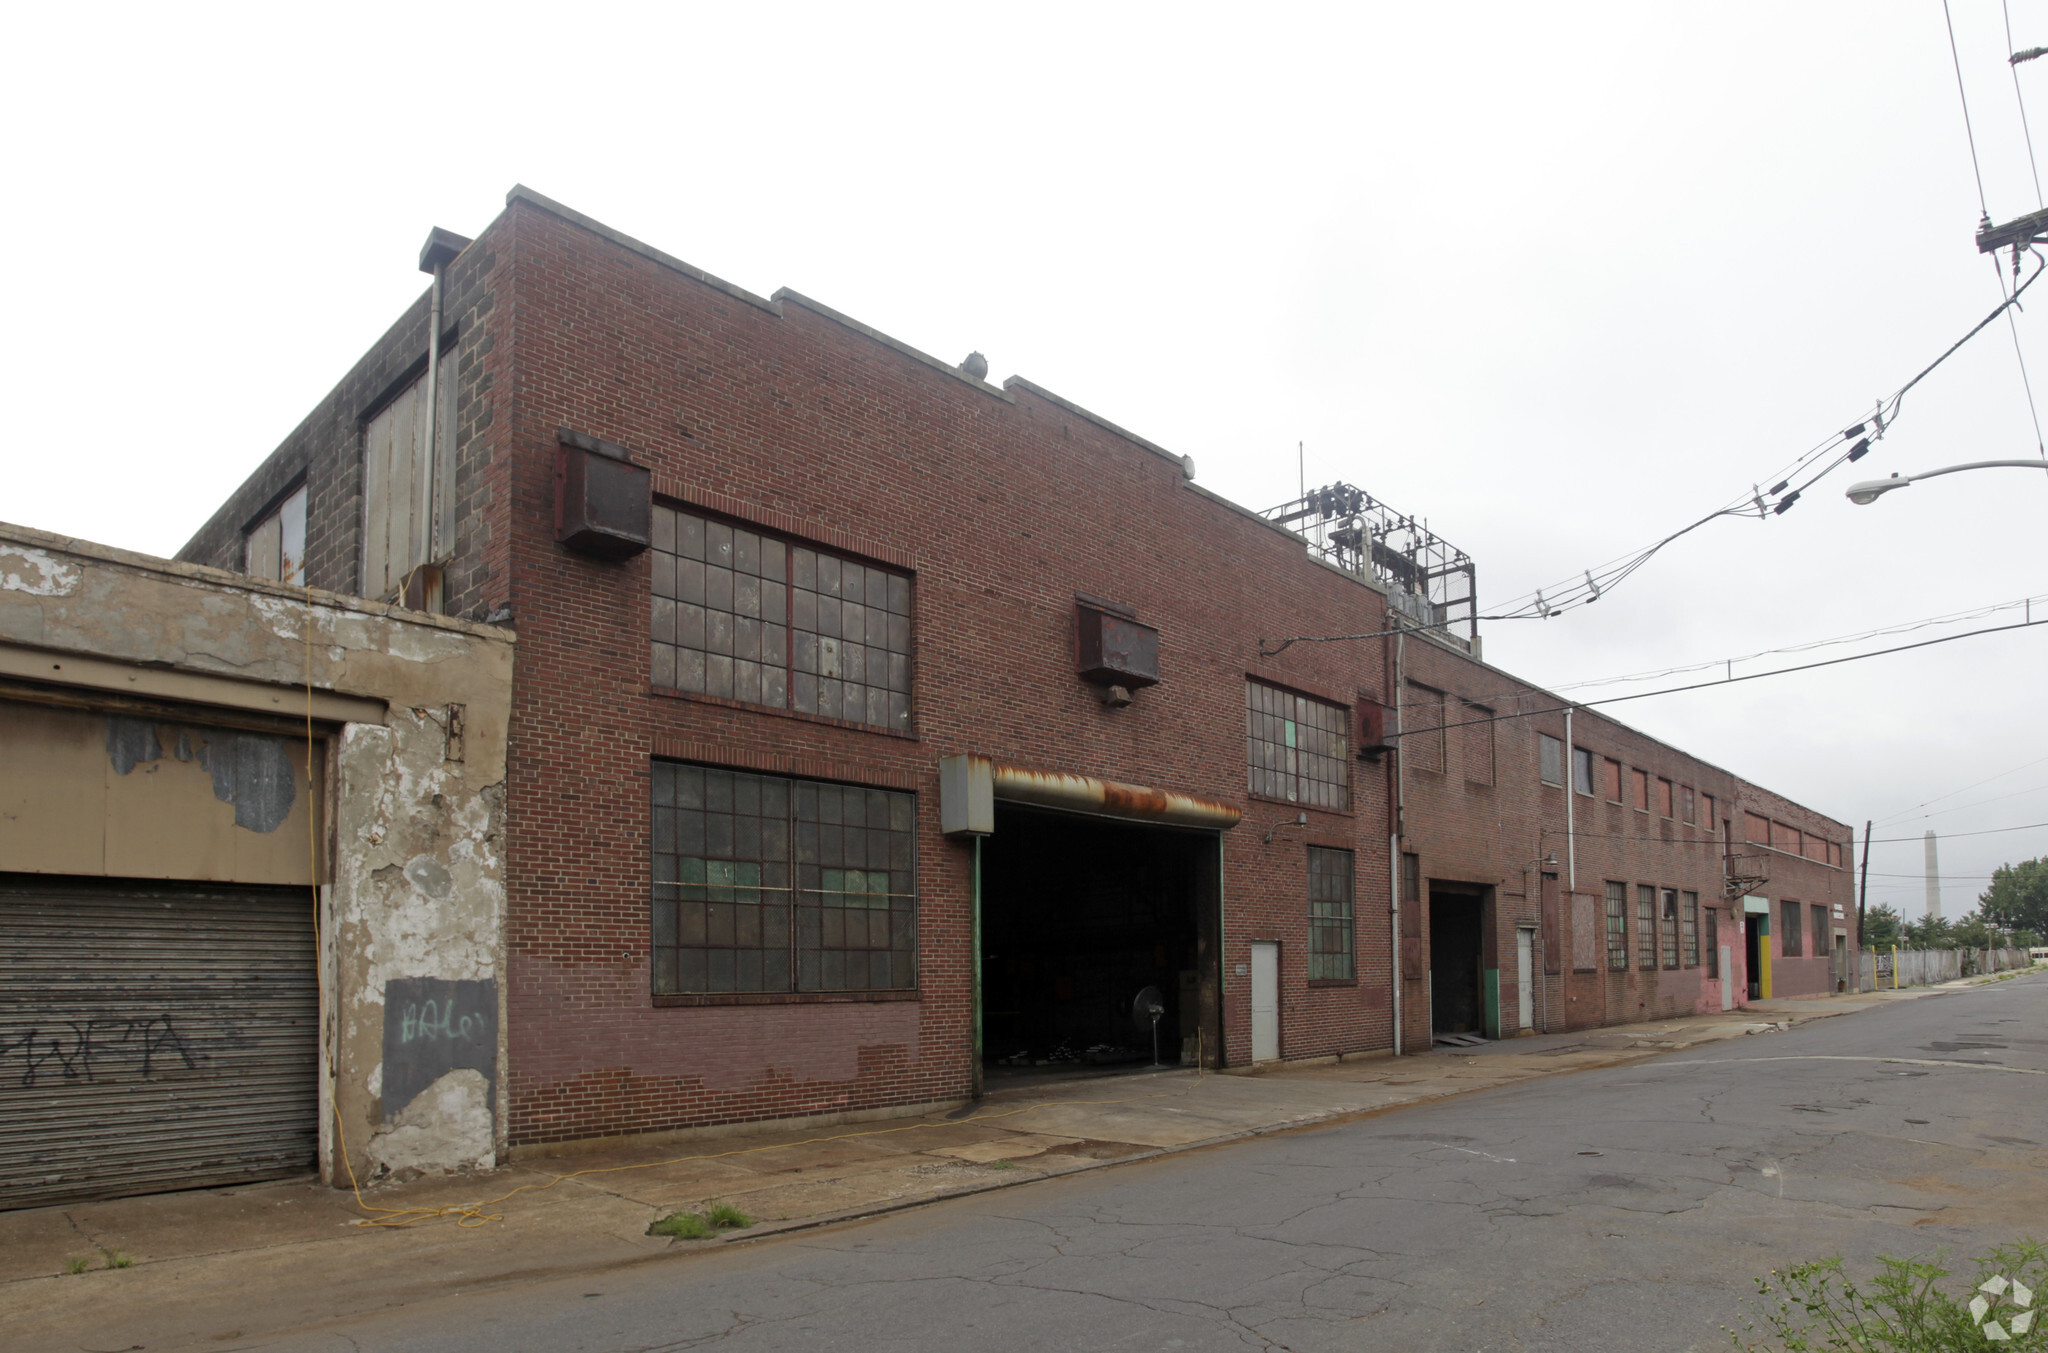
[1729,1240,2048,1353]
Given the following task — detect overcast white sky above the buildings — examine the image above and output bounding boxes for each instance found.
[0,0,2048,915]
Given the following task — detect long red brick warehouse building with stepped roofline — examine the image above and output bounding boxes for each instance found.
[180,188,1855,1150]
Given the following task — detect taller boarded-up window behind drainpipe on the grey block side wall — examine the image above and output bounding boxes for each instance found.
[362,352,455,600]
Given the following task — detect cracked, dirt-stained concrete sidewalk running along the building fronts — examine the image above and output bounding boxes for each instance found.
[0,978,1995,1349]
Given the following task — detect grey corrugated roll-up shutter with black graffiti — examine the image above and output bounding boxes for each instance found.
[0,874,319,1208]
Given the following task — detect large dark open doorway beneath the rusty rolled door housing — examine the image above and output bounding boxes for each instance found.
[981,809,1219,1081]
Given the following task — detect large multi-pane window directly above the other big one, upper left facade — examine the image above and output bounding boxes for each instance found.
[651,504,911,733]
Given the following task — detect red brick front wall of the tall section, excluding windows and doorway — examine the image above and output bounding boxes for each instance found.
[506,203,1417,1142]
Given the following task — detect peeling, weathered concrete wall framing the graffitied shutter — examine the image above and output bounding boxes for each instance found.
[0,524,512,1181]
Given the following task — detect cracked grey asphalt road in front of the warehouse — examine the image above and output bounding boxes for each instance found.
[264,976,2048,1353]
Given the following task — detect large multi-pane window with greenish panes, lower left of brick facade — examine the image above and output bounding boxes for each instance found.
[651,761,918,995]
